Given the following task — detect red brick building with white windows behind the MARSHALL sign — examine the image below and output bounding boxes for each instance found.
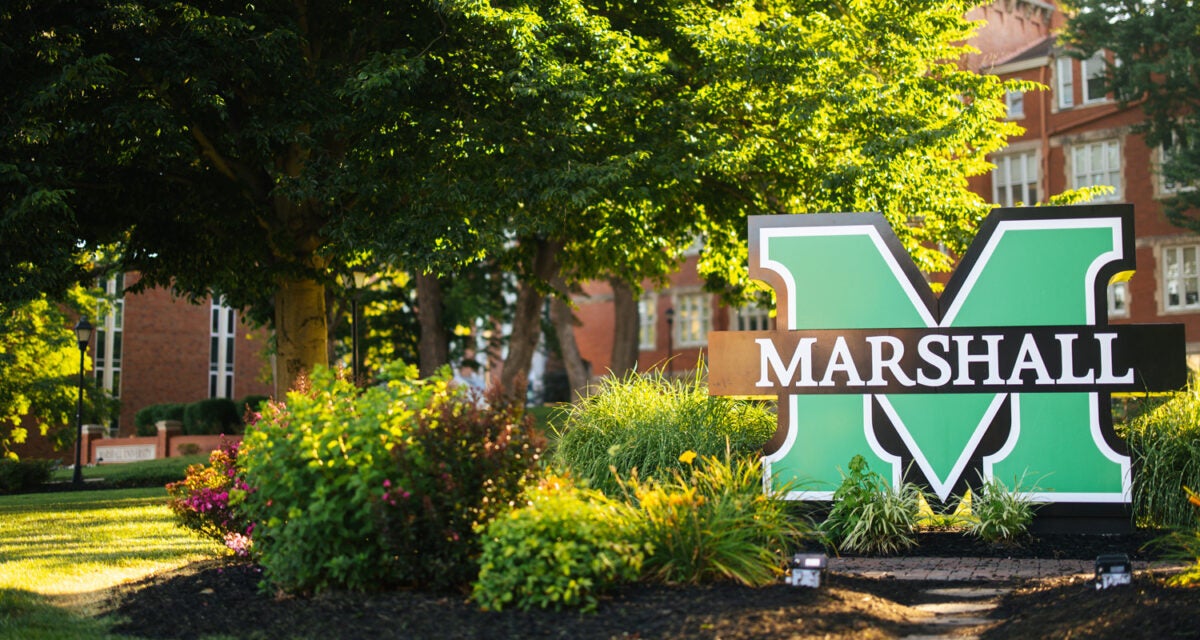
[575,0,1200,375]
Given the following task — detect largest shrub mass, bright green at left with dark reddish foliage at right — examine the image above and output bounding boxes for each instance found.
[242,365,538,591]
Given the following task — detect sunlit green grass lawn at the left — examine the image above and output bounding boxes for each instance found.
[0,489,221,640]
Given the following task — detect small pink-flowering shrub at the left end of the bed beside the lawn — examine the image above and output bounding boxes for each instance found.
[167,441,254,556]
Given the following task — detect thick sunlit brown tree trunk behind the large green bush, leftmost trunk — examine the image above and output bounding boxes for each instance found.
[275,273,329,399]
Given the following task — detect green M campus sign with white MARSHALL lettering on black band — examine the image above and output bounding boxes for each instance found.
[709,205,1187,512]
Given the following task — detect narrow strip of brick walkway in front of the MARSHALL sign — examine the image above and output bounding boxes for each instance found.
[828,557,1174,580]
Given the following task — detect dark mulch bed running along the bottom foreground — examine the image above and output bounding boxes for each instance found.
[109,533,1200,640]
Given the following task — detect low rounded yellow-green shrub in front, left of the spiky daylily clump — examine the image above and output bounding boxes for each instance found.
[472,475,652,611]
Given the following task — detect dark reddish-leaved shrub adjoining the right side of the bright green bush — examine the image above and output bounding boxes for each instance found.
[376,377,541,588]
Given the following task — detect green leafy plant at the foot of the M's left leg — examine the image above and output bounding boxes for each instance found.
[821,455,922,554]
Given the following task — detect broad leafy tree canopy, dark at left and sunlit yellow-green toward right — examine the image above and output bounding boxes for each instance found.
[0,0,1015,388]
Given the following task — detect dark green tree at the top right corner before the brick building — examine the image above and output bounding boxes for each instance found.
[1063,0,1200,231]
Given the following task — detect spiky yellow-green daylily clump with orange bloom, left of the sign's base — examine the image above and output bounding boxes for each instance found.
[623,451,809,586]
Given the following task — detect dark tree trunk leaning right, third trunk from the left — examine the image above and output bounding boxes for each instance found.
[500,239,563,399]
